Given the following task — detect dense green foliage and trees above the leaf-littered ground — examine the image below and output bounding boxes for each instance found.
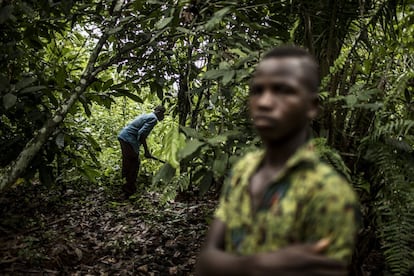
[0,0,414,275]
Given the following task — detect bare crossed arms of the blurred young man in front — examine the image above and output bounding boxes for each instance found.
[196,219,347,276]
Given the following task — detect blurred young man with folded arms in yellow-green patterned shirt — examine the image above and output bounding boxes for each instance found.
[197,46,357,276]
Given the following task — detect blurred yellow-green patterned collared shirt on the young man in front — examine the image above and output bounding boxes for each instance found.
[216,144,358,261]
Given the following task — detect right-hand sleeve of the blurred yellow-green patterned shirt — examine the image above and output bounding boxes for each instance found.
[306,175,359,262]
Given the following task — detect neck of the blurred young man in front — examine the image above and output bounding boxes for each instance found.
[264,129,308,167]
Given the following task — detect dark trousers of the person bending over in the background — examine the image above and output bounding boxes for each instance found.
[118,139,139,194]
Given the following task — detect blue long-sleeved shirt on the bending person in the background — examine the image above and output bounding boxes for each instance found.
[118,112,158,154]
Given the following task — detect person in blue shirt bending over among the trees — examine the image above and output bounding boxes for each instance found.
[118,106,165,196]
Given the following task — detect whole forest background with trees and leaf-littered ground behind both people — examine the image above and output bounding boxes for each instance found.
[0,0,414,275]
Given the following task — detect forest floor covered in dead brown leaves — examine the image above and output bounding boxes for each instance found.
[0,182,216,275]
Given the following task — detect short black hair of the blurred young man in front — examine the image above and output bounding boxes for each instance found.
[262,45,320,93]
